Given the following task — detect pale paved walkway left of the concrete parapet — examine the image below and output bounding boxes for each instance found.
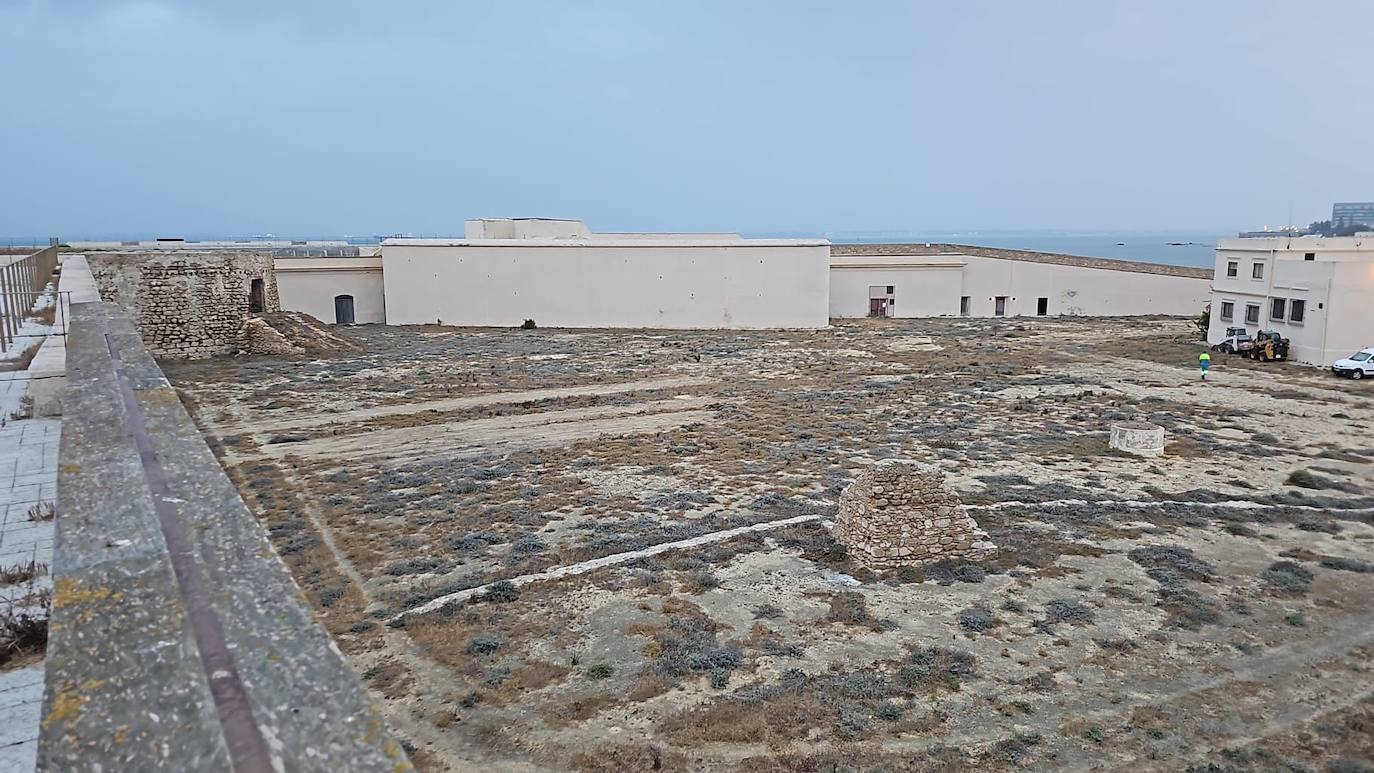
[0,372,62,773]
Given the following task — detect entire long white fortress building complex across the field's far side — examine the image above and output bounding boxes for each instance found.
[71,218,1212,336]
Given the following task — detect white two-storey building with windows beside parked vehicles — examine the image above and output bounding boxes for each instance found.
[1208,236,1374,365]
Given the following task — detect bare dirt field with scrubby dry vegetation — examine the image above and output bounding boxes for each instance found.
[166,319,1374,772]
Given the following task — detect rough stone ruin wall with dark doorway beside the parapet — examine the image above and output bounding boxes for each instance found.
[87,251,282,360]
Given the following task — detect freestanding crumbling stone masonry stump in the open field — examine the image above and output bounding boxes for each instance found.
[835,464,996,570]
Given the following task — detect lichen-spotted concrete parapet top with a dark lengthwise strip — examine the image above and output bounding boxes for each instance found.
[38,303,411,770]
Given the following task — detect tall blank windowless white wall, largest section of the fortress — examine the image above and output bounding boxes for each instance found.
[382,239,830,328]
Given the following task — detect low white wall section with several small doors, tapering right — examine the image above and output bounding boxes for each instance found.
[830,254,1210,317]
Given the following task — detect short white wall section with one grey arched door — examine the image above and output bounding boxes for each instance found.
[275,257,386,323]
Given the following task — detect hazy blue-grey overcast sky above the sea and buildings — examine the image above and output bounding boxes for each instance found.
[0,0,1374,238]
